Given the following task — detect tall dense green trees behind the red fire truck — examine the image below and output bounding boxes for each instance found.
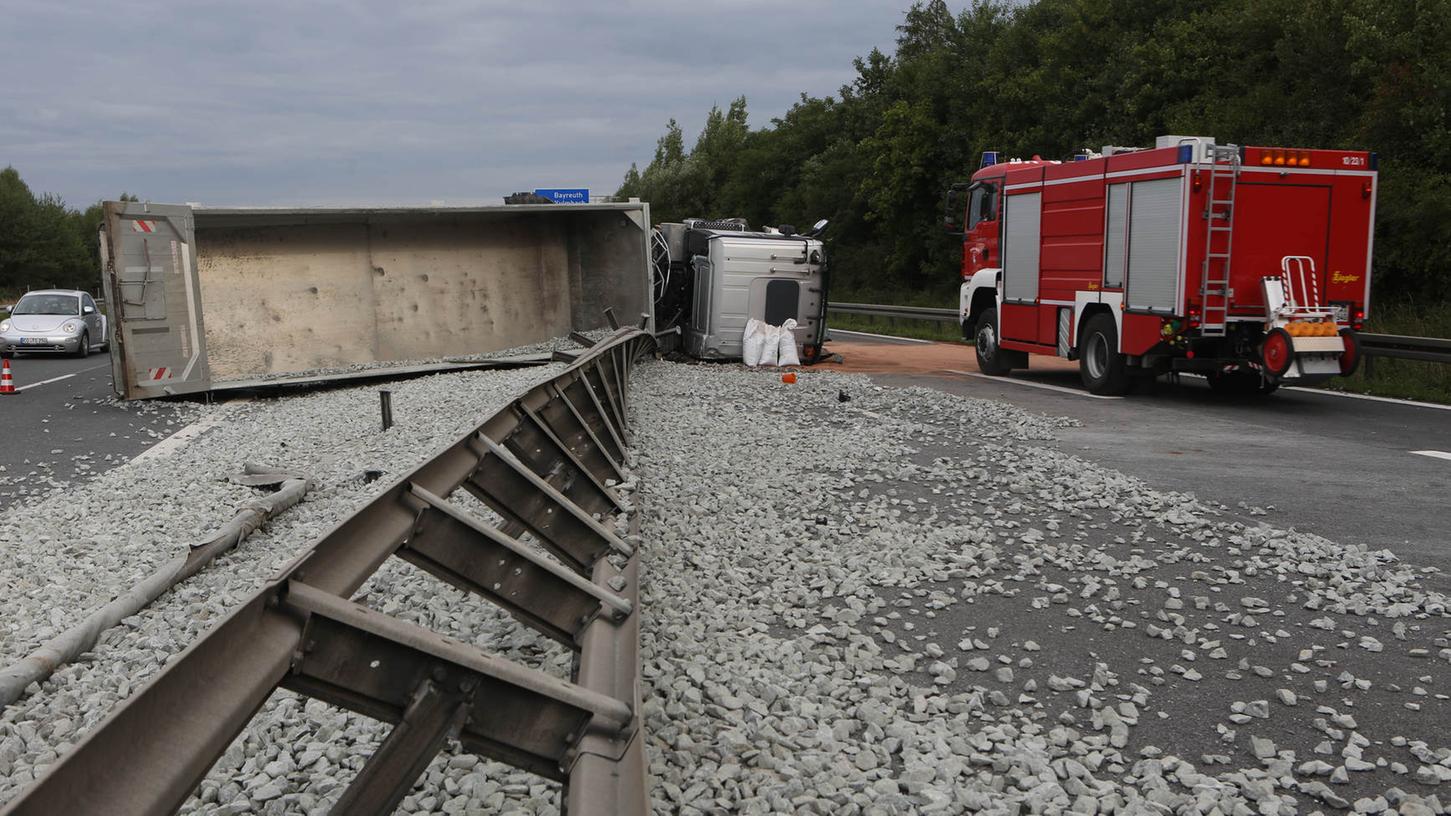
[620,0,1451,302]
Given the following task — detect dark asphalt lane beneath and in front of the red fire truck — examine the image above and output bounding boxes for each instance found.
[830,332,1451,572]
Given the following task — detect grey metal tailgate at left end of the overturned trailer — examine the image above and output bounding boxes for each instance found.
[102,202,210,399]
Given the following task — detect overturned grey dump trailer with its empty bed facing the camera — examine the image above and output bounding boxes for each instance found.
[102,202,653,399]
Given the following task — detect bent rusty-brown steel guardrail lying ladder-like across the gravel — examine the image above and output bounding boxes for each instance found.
[3,320,654,816]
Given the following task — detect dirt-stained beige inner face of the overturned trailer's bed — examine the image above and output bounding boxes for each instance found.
[197,215,577,382]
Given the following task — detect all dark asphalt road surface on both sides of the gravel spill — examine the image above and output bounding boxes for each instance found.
[0,331,1451,572]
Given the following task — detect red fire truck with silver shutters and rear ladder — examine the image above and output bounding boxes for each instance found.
[946,136,1376,393]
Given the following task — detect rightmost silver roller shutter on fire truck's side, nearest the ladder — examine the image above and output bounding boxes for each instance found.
[1126,177,1184,312]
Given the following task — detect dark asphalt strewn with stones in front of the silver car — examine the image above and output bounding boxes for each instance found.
[0,354,190,510]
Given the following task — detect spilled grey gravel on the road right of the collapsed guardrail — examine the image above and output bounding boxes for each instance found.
[631,364,1451,815]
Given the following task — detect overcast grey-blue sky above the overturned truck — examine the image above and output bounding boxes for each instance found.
[0,0,922,206]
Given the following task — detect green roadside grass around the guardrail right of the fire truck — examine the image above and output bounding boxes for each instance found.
[1322,303,1451,404]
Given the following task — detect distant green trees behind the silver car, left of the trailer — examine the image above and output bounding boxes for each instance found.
[0,167,135,295]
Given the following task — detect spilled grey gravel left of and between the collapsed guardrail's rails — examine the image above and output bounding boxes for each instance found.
[0,358,567,813]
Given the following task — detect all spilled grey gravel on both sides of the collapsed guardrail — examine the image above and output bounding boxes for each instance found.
[0,357,1451,815]
